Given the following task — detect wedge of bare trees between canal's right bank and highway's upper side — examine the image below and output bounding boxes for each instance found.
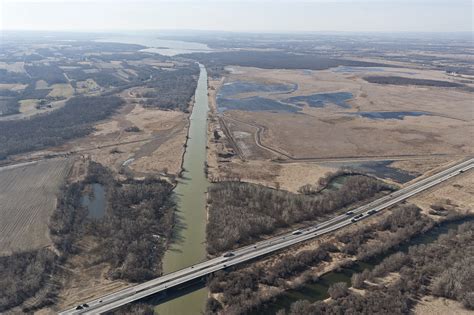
[206,176,392,254]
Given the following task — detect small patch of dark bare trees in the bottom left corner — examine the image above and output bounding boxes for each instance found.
[0,248,57,312]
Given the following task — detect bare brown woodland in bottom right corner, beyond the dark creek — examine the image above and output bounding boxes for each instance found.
[286,221,474,315]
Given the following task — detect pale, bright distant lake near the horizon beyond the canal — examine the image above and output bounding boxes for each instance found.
[97,34,214,56]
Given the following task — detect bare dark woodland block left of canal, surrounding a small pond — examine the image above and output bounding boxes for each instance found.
[50,162,175,282]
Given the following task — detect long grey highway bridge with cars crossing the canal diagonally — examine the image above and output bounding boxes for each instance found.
[60,159,474,314]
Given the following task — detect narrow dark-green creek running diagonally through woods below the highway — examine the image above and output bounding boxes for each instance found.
[251,217,474,315]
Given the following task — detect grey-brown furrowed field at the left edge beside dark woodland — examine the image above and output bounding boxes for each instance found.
[0,159,70,255]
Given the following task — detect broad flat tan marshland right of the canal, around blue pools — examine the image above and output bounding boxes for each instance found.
[218,67,474,159]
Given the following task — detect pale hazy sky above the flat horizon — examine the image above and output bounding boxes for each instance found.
[0,0,474,32]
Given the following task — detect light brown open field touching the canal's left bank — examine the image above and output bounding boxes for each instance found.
[16,91,189,176]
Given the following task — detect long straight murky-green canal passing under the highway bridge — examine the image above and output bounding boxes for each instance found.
[155,65,209,315]
